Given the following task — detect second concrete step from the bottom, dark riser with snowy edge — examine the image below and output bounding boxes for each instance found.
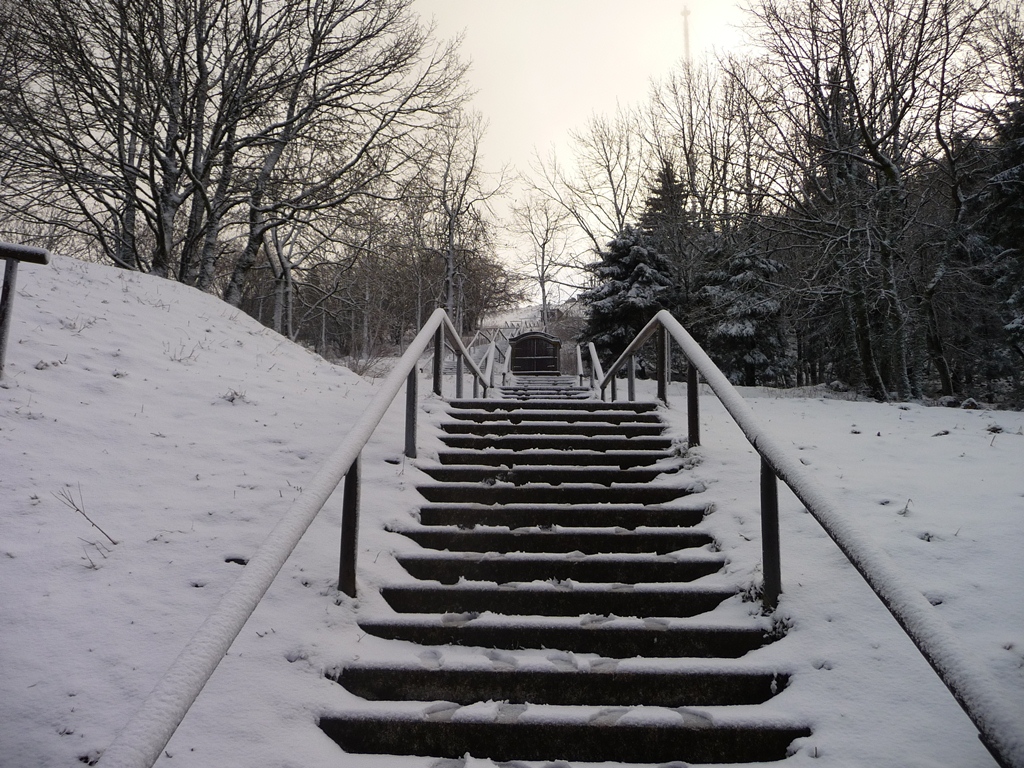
[334,663,788,707]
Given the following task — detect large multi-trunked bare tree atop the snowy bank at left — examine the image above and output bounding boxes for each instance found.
[0,0,463,303]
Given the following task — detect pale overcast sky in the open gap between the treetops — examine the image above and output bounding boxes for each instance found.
[414,0,741,172]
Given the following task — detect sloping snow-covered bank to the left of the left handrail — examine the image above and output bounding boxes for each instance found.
[0,257,400,767]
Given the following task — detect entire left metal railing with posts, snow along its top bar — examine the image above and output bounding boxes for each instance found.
[99,309,489,768]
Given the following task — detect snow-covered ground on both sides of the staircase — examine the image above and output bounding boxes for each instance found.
[0,258,1024,768]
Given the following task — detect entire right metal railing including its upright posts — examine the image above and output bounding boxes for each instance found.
[590,309,1024,768]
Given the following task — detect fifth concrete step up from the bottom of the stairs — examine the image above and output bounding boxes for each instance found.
[397,552,726,584]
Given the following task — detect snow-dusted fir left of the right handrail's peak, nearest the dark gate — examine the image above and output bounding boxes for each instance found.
[581,225,676,362]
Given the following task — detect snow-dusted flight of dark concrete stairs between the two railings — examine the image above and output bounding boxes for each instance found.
[321,377,810,764]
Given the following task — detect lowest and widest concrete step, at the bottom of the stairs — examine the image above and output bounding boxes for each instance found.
[319,705,810,764]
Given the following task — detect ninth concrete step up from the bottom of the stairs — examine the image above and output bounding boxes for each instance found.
[420,465,680,486]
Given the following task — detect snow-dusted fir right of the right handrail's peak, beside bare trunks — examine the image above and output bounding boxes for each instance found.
[700,249,787,386]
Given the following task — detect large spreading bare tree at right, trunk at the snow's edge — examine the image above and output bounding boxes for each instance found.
[753,0,991,399]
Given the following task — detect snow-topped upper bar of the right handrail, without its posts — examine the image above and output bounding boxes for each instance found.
[600,309,1024,768]
